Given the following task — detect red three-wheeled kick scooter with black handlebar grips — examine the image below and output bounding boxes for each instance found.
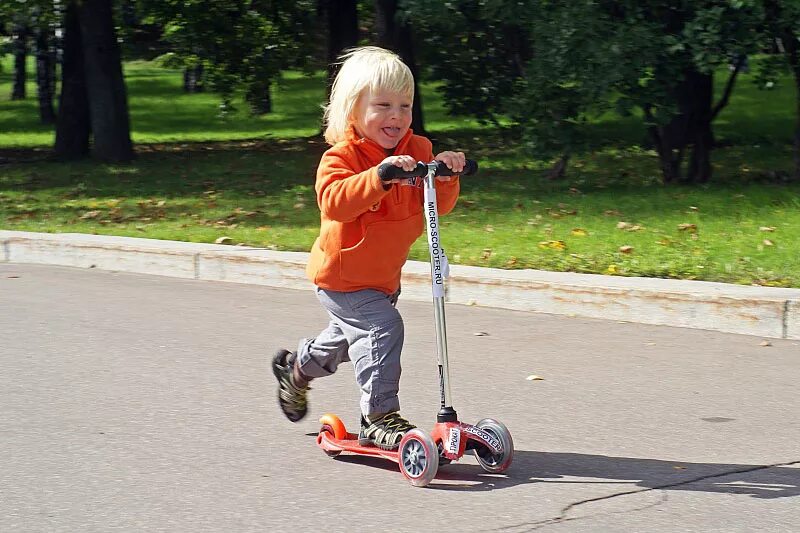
[317,160,514,487]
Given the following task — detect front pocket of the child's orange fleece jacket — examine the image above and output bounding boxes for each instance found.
[339,213,423,285]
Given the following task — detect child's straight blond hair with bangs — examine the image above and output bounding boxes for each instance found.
[323,46,414,145]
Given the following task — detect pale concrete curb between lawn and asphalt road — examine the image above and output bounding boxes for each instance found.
[0,230,800,339]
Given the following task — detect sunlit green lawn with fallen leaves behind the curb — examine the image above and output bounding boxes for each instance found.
[0,56,800,287]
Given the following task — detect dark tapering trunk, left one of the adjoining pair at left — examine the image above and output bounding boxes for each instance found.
[54,3,91,159]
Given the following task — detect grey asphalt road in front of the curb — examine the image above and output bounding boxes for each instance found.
[0,264,800,533]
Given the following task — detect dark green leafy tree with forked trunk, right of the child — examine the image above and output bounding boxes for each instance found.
[403,0,776,181]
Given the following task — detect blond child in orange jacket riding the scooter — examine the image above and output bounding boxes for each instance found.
[272,47,465,450]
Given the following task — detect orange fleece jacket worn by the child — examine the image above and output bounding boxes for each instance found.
[306,126,459,294]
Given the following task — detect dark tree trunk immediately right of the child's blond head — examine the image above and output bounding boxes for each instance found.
[375,0,425,135]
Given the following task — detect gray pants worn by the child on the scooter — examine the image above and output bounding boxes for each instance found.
[297,287,404,415]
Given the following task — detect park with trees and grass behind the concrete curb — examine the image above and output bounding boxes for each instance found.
[0,0,800,287]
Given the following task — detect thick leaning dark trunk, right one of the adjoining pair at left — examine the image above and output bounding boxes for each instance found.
[78,0,133,161]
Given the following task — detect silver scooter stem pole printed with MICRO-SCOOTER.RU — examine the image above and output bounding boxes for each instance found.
[423,163,458,422]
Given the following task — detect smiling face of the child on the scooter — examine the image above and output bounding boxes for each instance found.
[356,90,412,149]
